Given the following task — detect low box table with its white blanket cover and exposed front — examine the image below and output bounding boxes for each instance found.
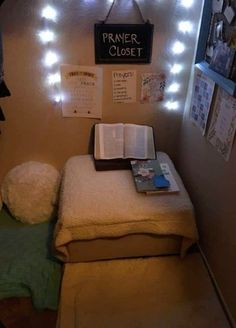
[54,152,198,262]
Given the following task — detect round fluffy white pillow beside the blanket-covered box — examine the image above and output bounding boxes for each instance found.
[1,162,60,224]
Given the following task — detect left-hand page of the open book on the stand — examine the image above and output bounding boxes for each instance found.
[94,123,124,159]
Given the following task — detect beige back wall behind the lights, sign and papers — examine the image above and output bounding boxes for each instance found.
[0,0,203,181]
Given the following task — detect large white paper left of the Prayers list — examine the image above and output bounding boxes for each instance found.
[61,65,103,118]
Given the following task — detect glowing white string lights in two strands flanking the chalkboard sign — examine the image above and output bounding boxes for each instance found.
[38,0,196,110]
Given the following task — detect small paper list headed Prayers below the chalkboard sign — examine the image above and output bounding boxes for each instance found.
[112,70,136,103]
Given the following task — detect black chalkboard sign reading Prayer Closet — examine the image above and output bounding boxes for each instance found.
[94,23,154,64]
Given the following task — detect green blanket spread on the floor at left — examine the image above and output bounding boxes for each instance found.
[0,207,62,310]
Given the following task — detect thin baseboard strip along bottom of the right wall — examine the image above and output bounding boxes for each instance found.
[197,244,236,328]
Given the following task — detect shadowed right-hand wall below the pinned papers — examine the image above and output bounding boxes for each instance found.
[178,86,236,318]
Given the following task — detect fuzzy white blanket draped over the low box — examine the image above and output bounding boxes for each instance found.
[55,152,198,260]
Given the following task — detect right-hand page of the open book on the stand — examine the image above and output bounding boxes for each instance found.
[124,124,156,159]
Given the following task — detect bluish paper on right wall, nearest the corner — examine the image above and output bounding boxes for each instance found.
[190,70,215,135]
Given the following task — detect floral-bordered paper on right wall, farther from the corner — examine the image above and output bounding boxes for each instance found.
[207,89,236,161]
